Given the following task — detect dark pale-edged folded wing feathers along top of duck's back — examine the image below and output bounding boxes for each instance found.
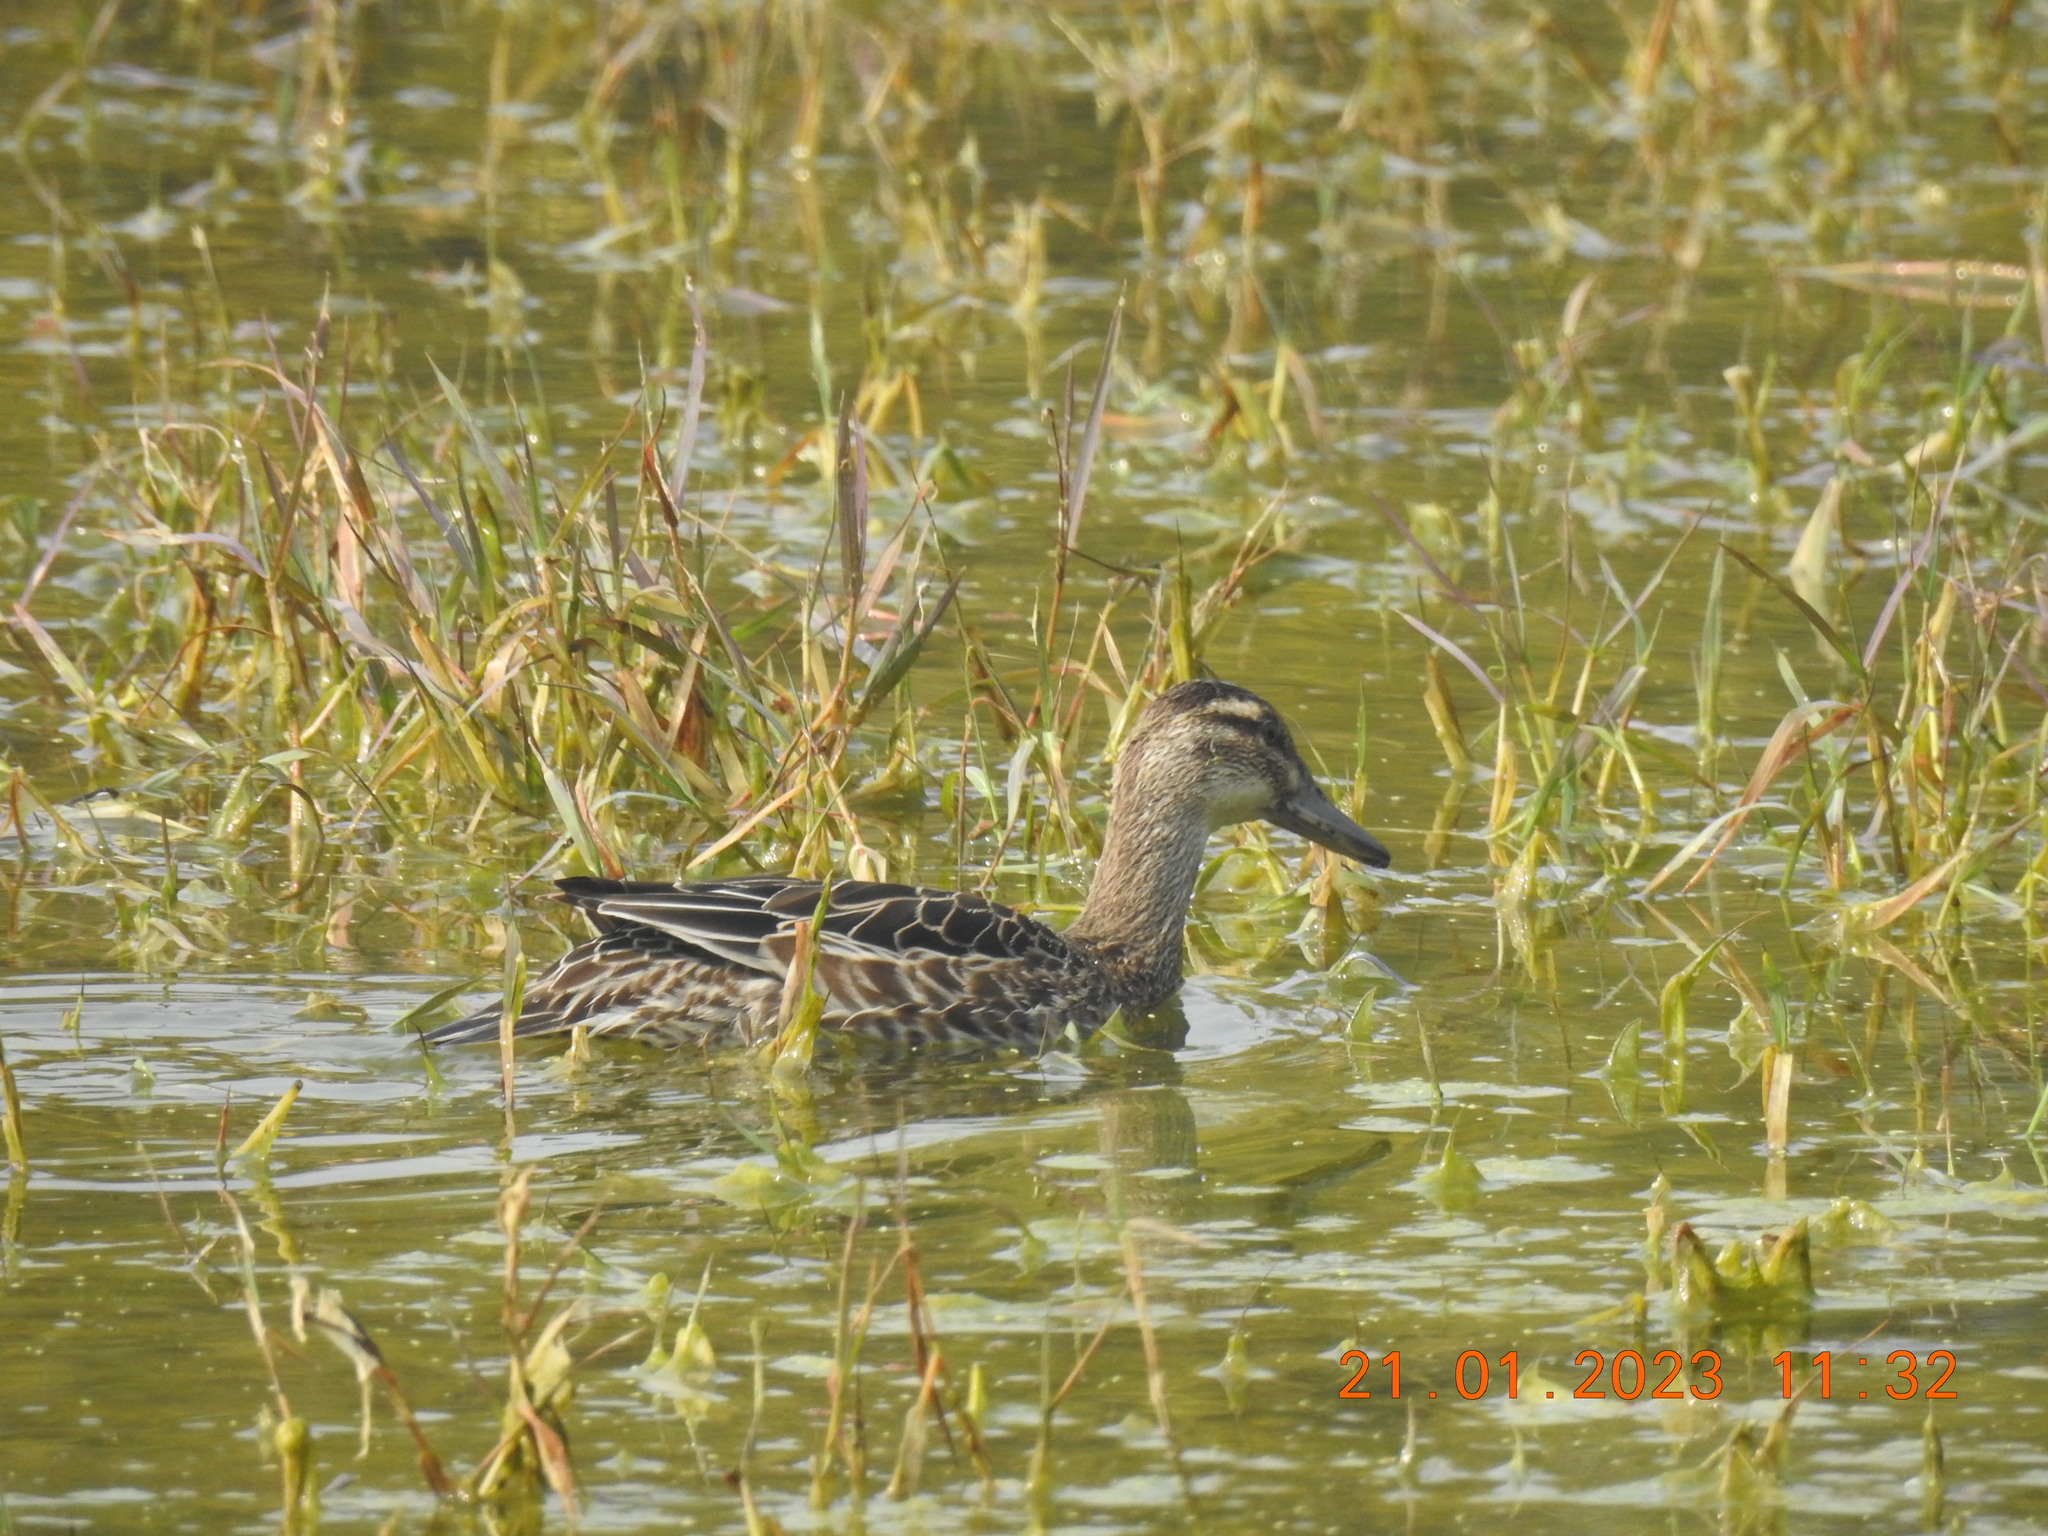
[557,877,1065,977]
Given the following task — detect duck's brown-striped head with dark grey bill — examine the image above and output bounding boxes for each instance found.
[1116,680,1393,868]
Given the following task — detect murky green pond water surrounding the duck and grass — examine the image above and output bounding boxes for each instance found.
[0,2,2048,1532]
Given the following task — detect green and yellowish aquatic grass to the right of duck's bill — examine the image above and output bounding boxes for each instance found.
[1382,284,2042,950]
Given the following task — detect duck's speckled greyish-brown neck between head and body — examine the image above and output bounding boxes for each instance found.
[1067,762,1208,1010]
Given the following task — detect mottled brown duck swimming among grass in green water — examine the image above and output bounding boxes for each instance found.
[426,680,1393,1051]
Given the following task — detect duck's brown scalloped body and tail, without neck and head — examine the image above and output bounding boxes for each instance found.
[428,877,1112,1047]
